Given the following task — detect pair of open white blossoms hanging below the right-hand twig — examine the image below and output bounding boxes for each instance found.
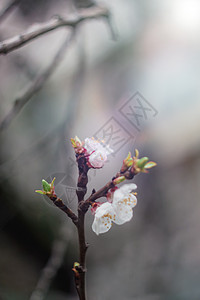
[92,183,137,235]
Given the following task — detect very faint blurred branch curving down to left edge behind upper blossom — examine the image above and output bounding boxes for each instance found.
[0,28,86,182]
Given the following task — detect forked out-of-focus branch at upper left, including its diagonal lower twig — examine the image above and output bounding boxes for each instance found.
[0,7,116,130]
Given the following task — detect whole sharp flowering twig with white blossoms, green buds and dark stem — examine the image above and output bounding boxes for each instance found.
[36,136,156,299]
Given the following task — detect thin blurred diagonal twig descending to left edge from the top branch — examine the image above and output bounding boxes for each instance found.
[0,31,74,130]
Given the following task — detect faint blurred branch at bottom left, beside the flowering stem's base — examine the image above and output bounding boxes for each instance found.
[30,221,72,300]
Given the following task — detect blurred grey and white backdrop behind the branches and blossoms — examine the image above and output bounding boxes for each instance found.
[0,0,200,300]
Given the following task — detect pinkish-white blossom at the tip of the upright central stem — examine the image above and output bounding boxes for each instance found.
[84,138,113,168]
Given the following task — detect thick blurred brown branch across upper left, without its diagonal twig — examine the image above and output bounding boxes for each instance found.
[0,7,109,54]
